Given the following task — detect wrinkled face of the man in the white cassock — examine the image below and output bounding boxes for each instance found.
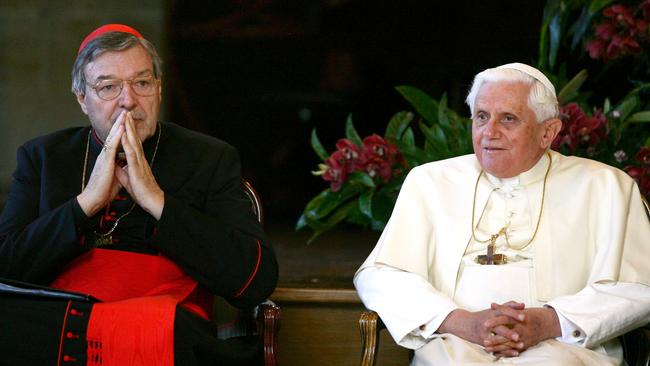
[472,82,561,178]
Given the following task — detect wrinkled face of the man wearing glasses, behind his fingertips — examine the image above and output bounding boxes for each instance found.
[77,45,161,141]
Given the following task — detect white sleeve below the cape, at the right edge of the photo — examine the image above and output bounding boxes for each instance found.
[547,282,650,348]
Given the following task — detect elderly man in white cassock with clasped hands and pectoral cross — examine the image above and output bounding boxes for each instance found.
[354,63,650,366]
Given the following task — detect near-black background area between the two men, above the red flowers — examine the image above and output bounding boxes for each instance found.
[165,0,543,221]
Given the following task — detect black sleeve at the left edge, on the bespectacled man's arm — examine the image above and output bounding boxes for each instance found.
[0,147,85,285]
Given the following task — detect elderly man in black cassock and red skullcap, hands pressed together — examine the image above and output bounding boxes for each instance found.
[0,24,277,366]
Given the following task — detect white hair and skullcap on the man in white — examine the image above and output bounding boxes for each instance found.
[465,67,559,123]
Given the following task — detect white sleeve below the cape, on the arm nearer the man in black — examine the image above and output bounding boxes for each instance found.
[354,265,458,349]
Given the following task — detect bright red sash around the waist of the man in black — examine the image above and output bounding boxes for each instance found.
[51,249,211,366]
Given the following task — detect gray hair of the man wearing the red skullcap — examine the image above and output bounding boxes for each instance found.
[72,32,162,95]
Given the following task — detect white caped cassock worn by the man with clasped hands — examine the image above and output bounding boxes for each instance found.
[354,151,650,365]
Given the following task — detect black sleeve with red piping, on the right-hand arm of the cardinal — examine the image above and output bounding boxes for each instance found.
[156,147,278,307]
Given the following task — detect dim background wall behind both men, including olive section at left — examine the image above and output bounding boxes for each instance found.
[0,0,543,227]
